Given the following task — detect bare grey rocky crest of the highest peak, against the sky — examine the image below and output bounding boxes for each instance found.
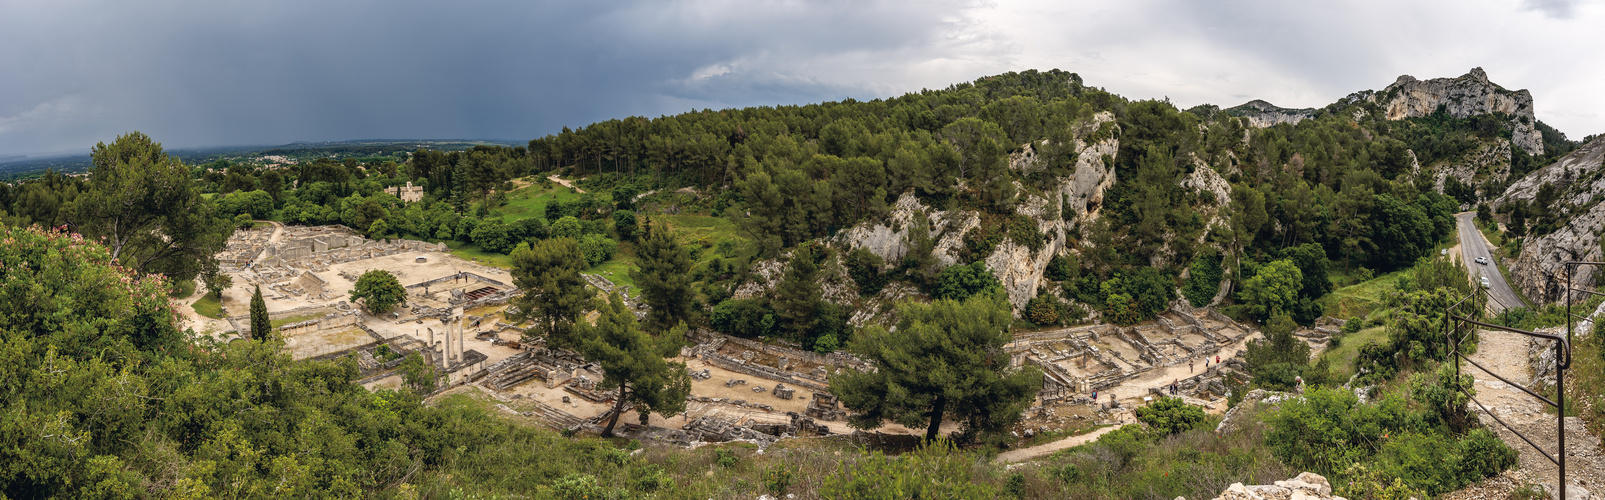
[1382,67,1544,155]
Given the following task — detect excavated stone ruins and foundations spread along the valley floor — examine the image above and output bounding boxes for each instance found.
[191,224,1296,444]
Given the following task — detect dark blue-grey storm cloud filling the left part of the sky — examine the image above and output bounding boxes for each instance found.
[0,2,988,152]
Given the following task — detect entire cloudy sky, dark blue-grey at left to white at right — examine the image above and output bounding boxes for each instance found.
[0,0,1605,155]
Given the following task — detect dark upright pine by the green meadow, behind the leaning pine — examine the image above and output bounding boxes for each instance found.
[629,221,692,330]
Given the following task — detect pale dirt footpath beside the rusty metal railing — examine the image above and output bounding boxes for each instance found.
[1461,330,1605,497]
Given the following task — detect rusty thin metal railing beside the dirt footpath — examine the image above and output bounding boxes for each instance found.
[1443,277,1575,498]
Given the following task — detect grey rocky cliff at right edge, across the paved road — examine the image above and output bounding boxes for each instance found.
[1491,138,1605,303]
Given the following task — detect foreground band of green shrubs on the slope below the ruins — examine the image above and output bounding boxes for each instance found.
[0,226,1515,498]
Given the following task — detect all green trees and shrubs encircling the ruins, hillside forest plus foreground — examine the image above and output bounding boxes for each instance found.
[0,71,1576,498]
